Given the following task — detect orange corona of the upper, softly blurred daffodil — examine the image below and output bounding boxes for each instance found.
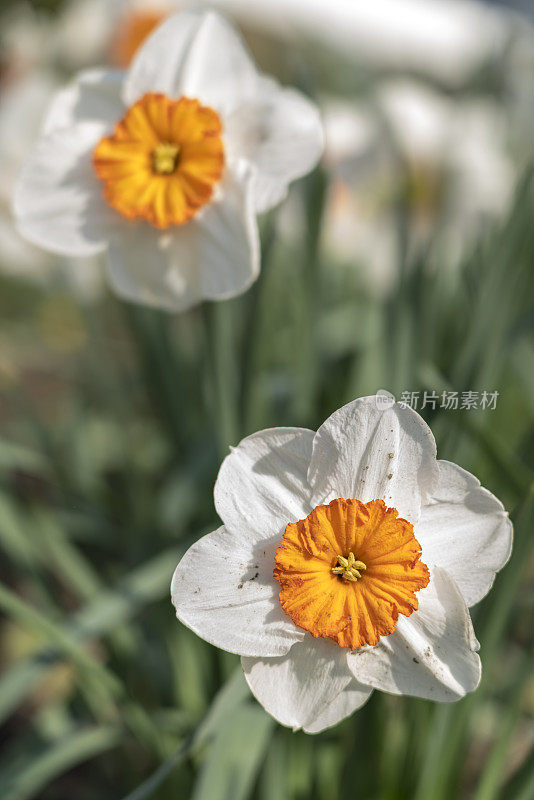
[93,94,224,228]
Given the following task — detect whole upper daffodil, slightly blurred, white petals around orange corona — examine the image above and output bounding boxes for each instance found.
[14,12,323,311]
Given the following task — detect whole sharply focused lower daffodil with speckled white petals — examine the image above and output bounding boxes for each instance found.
[171,397,512,733]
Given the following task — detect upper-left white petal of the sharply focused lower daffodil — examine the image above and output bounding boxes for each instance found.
[215,428,314,540]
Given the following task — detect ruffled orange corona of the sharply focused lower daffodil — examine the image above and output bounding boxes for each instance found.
[273,498,430,649]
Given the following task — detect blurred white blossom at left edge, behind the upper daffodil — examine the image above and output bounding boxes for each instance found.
[0,69,102,300]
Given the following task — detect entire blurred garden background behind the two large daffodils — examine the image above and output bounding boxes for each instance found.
[0,0,534,800]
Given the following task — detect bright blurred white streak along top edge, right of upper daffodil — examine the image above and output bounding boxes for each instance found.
[211,0,515,85]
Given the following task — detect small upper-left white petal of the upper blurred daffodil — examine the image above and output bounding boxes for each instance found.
[43,69,125,135]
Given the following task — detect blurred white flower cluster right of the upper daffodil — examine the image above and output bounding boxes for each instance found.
[324,80,517,293]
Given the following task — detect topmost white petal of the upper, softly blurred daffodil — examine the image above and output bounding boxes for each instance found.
[124,11,258,114]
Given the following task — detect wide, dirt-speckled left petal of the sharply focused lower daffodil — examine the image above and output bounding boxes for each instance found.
[171,527,304,656]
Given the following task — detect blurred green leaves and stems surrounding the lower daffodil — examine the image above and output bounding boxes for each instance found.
[0,159,534,800]
